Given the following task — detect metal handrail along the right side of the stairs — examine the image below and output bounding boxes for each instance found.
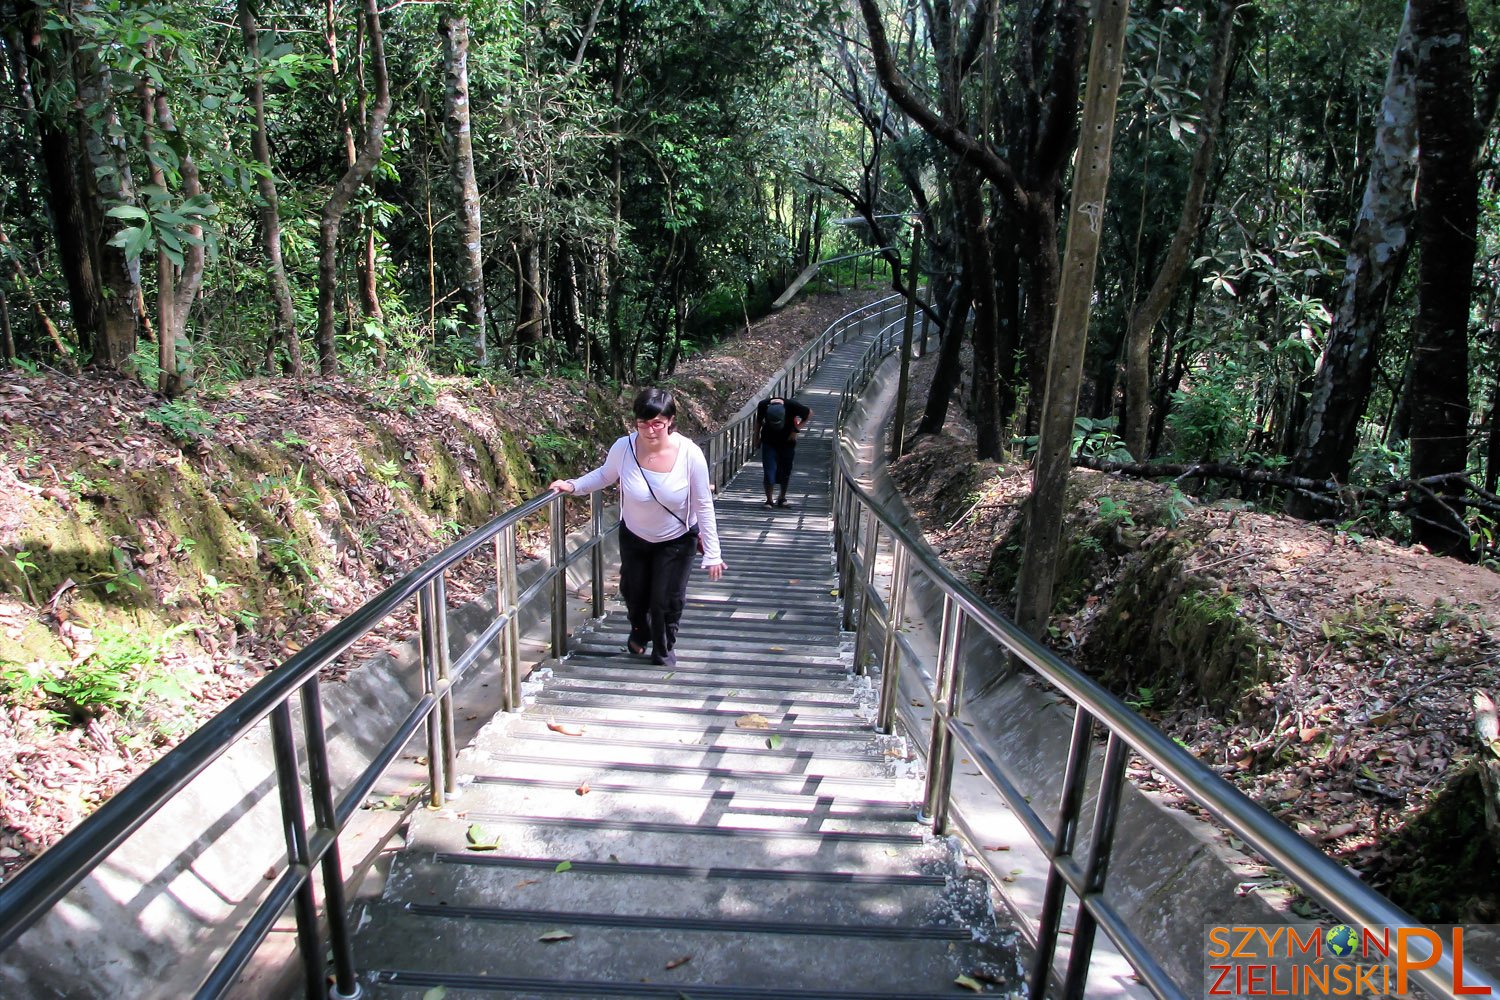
[833,331,1500,997]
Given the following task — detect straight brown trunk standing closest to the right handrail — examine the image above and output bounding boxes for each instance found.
[1016,0,1130,637]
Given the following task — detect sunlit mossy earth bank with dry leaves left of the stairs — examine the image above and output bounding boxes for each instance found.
[0,291,884,873]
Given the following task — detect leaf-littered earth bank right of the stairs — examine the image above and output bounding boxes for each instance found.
[891,350,1500,924]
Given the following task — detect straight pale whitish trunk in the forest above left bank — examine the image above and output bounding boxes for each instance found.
[438,9,489,367]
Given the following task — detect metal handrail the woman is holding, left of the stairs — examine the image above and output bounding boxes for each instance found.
[0,295,903,1000]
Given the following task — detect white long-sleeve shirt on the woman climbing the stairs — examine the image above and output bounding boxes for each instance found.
[569,430,723,568]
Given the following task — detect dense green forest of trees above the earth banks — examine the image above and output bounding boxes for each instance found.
[0,0,1500,911]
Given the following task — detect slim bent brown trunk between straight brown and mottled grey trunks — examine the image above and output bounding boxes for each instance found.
[1121,0,1242,462]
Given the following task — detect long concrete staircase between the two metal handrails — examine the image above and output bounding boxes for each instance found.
[354,334,1020,1000]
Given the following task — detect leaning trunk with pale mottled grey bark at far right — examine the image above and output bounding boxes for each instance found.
[1287,6,1418,517]
